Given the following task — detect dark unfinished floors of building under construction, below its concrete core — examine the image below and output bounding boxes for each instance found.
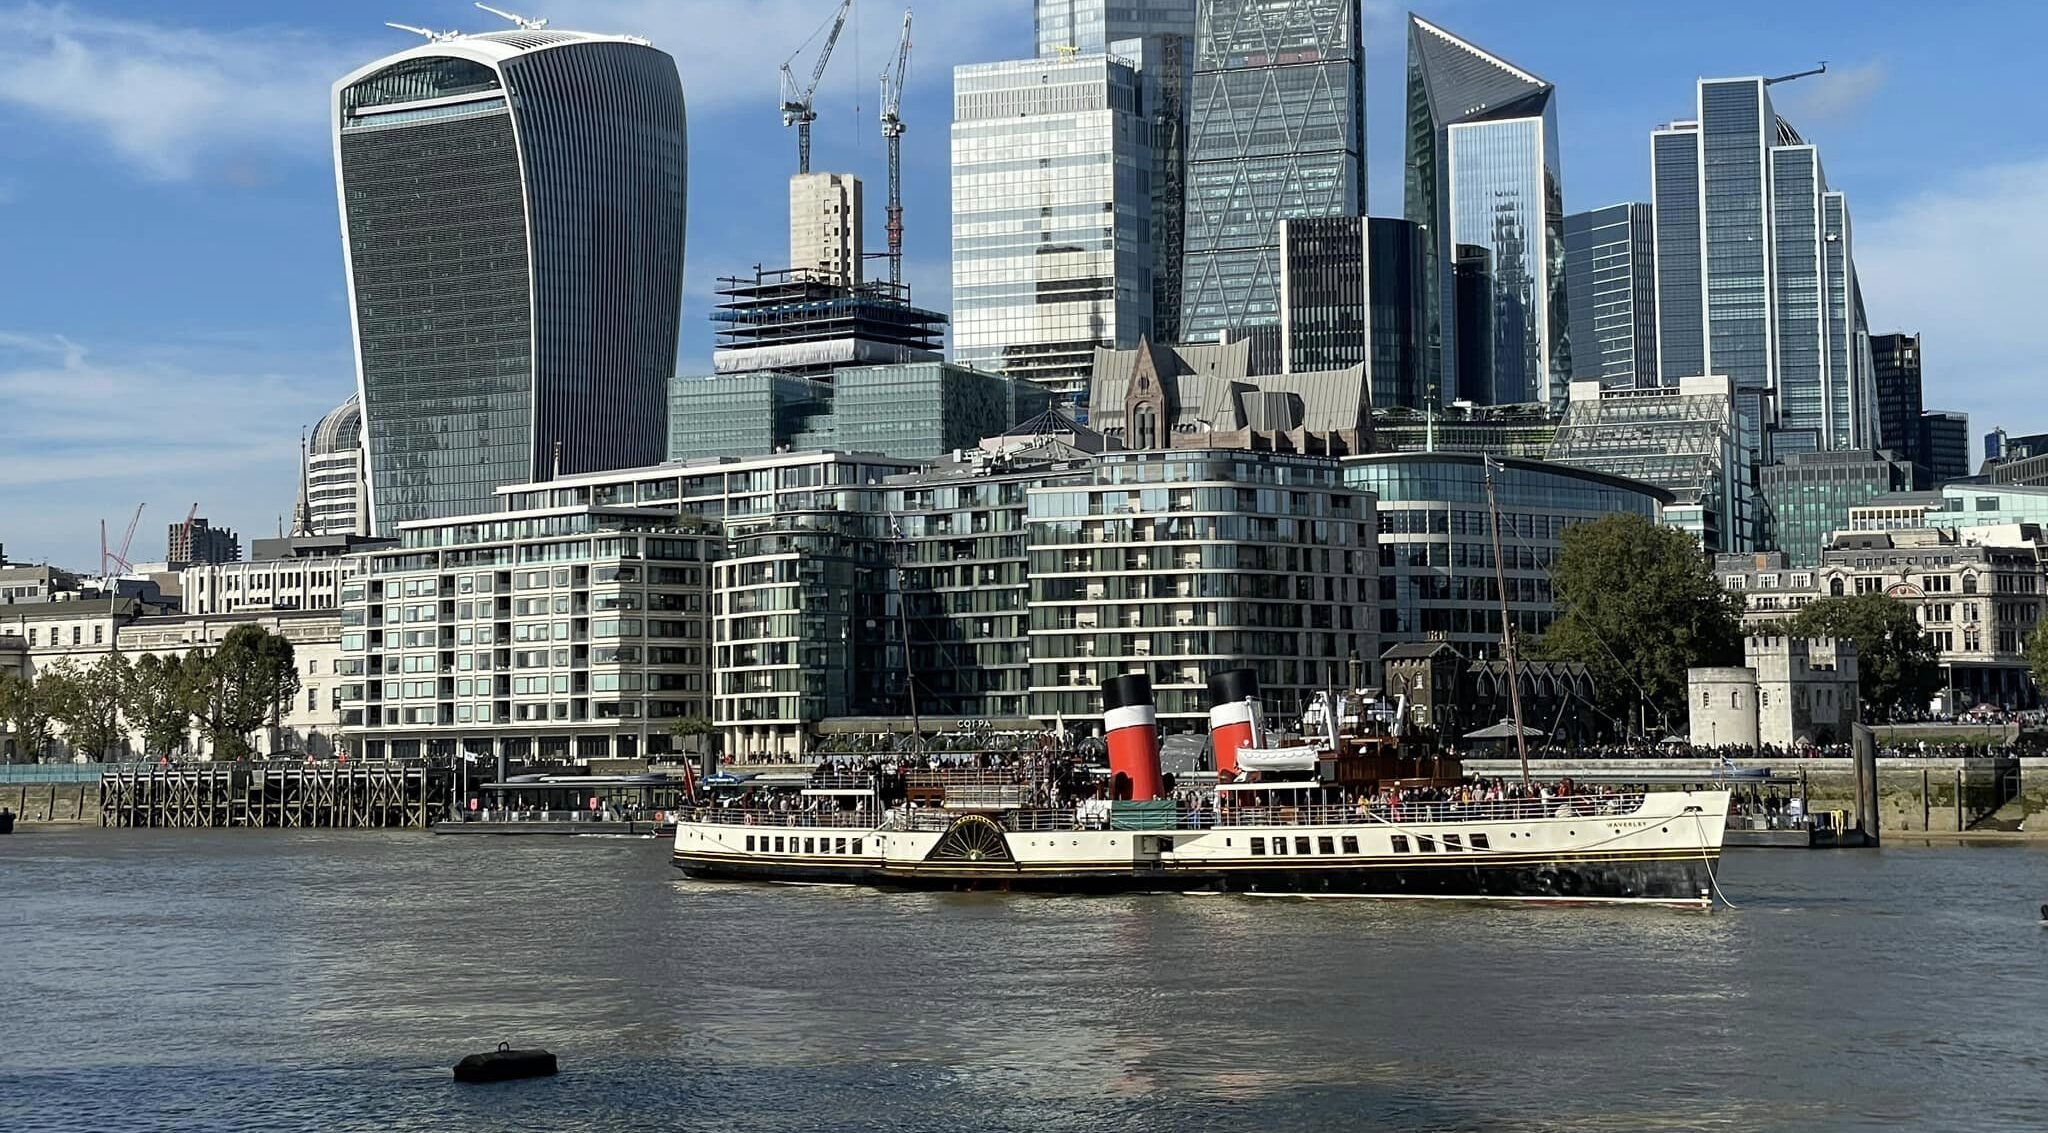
[711,268,946,381]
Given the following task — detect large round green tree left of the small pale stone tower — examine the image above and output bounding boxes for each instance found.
[1532,512,1743,727]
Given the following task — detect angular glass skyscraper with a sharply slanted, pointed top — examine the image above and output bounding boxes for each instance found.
[1405,14,1573,408]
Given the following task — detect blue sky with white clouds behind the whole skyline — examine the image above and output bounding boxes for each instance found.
[0,0,2048,568]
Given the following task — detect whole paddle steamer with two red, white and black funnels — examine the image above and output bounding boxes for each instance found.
[674,670,1729,906]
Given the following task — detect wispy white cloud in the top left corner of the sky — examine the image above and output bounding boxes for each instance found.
[0,4,371,180]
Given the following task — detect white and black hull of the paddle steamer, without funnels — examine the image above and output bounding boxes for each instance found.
[674,791,1729,906]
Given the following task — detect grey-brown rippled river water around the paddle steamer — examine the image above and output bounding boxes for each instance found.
[0,830,2048,1133]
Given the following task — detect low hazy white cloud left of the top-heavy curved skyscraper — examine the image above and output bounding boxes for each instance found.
[0,330,348,568]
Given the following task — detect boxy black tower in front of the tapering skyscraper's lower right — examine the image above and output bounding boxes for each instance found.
[1280,217,1427,410]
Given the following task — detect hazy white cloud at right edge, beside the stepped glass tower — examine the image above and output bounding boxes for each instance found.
[1855,158,2048,432]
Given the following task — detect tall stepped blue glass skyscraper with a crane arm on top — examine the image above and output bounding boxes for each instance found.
[1651,78,1878,453]
